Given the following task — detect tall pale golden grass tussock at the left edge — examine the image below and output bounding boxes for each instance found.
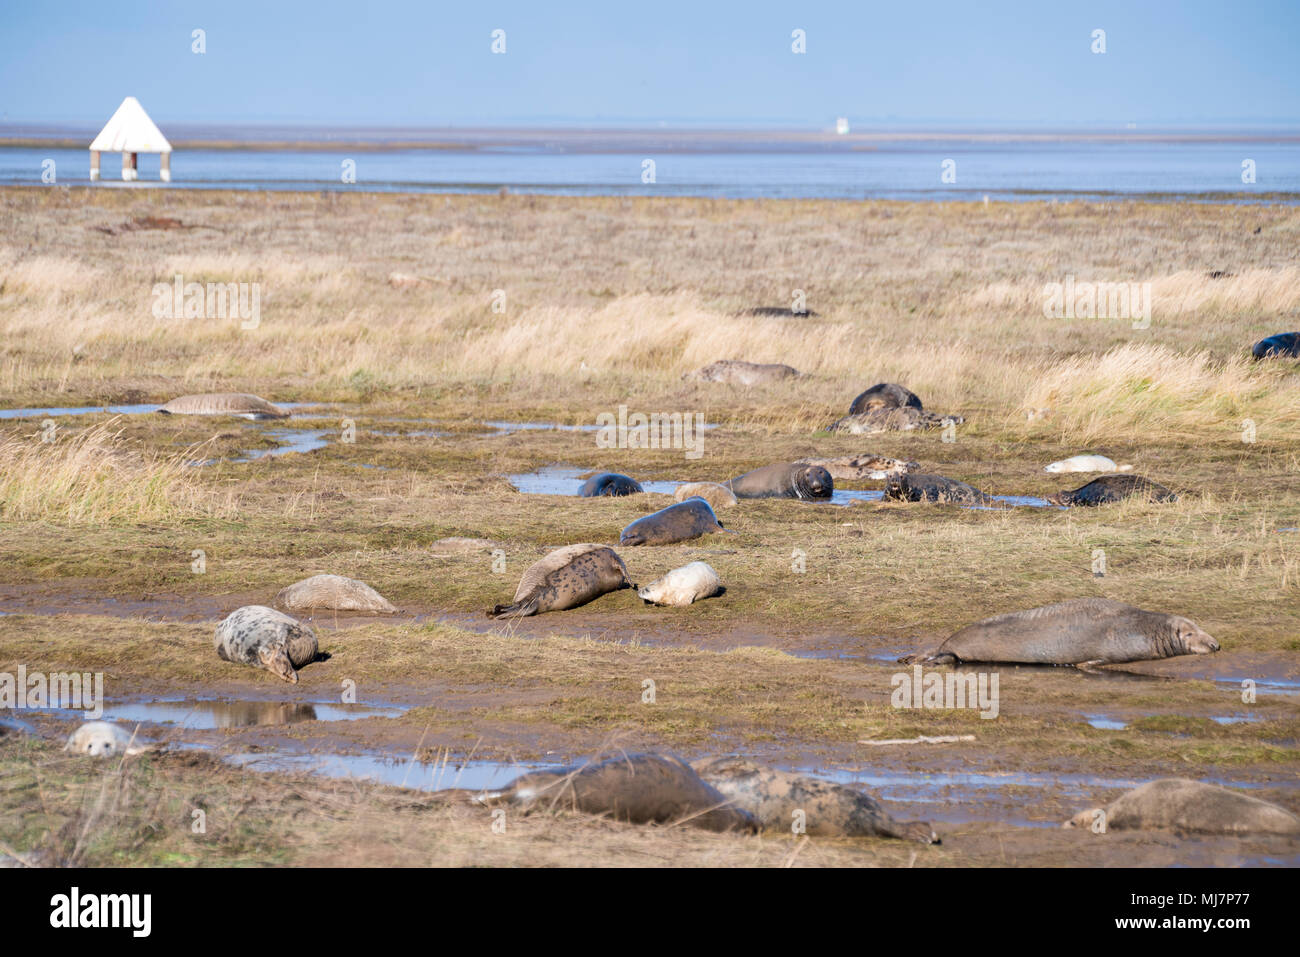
[0,419,221,524]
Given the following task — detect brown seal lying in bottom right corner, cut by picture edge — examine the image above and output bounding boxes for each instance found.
[1062,778,1300,835]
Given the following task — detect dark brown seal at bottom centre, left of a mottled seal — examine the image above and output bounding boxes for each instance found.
[475,754,758,832]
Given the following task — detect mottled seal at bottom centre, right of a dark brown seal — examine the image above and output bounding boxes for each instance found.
[692,757,940,844]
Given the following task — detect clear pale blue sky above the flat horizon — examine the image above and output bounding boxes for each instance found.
[0,0,1300,127]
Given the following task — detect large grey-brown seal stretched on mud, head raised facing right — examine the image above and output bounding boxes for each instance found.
[898,598,1219,667]
